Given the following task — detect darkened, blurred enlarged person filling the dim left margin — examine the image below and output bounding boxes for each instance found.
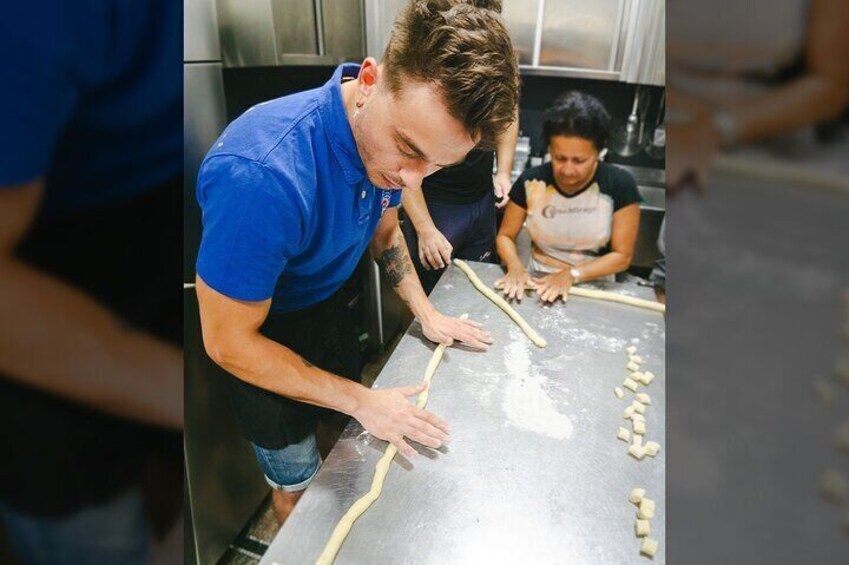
[0,0,183,563]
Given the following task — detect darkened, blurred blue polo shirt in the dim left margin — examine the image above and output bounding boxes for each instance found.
[0,0,183,214]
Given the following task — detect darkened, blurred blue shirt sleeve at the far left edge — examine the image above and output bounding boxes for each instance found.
[0,2,79,188]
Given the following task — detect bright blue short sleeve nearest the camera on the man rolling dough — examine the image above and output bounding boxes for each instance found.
[197,155,306,302]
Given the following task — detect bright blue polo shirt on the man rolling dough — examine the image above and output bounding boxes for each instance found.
[197,64,401,312]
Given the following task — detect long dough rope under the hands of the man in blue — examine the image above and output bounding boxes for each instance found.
[315,314,469,565]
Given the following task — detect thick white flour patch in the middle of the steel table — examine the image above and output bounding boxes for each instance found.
[504,328,573,439]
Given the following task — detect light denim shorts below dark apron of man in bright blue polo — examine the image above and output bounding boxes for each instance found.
[251,434,321,492]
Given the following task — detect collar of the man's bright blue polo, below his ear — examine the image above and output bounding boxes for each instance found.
[318,63,366,186]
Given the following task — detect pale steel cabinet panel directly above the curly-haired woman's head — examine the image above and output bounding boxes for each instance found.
[539,0,620,70]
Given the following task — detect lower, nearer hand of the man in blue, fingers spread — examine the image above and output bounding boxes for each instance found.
[352,383,450,457]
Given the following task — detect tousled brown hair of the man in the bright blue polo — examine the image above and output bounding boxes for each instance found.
[383,0,519,149]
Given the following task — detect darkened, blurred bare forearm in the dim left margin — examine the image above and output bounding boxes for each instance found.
[0,259,183,429]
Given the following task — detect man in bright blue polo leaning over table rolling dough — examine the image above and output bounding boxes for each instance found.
[197,2,518,522]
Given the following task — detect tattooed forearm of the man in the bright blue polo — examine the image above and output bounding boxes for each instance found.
[372,226,434,320]
